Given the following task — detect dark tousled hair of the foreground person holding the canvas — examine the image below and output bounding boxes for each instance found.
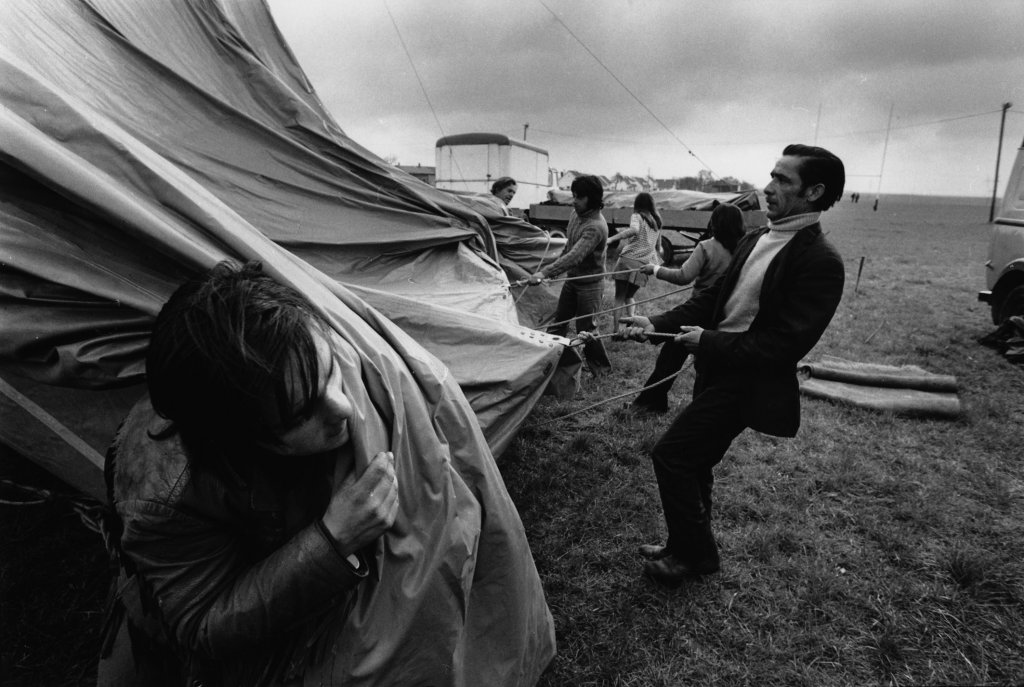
[145,262,330,469]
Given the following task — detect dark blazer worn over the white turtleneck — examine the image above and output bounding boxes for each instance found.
[651,223,846,436]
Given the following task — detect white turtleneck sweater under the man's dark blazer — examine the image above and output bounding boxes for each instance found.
[716,212,821,332]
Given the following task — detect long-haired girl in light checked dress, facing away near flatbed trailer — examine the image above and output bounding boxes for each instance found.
[608,191,662,327]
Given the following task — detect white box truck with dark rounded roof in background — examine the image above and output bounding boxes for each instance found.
[434,133,551,210]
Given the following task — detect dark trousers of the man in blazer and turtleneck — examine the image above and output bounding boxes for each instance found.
[651,378,746,562]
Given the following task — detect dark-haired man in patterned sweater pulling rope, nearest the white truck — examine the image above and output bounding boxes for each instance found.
[528,175,611,376]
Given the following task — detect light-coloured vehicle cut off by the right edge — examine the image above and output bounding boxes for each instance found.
[978,143,1024,325]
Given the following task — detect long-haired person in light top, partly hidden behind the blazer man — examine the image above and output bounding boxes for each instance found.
[632,200,744,413]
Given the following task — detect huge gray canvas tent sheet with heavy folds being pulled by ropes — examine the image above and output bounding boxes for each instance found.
[0,0,562,685]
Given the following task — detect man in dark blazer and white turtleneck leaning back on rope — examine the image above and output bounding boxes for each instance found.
[624,144,846,586]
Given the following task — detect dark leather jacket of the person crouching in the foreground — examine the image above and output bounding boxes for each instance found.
[108,398,369,685]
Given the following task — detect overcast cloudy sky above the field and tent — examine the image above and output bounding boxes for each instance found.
[270,0,1024,196]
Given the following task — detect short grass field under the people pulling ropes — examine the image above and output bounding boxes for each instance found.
[0,193,1024,687]
